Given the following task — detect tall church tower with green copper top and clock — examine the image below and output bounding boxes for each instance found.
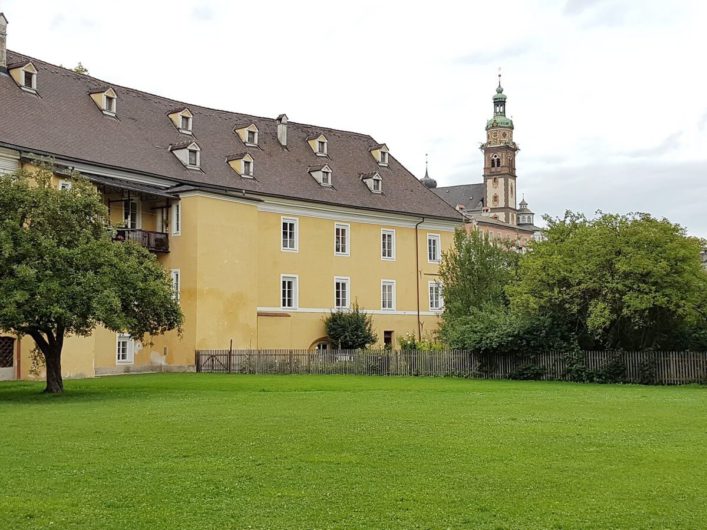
[481,74,519,225]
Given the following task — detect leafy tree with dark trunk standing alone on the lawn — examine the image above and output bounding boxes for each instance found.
[0,168,182,393]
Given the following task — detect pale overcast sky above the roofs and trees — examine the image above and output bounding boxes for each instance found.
[0,0,707,237]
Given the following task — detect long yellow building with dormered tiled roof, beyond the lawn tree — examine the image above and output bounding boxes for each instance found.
[0,16,462,378]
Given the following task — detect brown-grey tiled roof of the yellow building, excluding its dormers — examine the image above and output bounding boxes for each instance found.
[0,51,461,220]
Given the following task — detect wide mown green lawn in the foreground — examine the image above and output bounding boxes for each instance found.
[0,374,707,529]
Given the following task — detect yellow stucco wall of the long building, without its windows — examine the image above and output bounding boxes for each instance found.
[4,163,457,378]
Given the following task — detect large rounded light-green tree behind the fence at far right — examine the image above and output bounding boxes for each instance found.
[507,212,707,350]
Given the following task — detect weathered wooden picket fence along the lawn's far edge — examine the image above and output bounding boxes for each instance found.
[196,350,707,385]
